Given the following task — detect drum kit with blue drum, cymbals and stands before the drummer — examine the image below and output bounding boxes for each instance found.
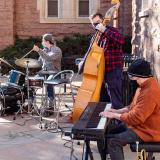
[0,50,52,119]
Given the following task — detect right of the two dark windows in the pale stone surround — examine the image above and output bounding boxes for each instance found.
[78,0,89,17]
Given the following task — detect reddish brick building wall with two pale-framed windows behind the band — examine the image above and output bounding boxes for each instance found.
[0,0,132,49]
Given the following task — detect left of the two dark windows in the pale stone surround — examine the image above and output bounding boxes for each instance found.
[47,0,58,17]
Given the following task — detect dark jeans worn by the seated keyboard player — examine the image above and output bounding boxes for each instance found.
[97,120,142,160]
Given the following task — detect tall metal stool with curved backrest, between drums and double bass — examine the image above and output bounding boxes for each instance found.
[40,70,74,129]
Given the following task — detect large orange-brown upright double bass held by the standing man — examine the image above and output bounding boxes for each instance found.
[72,3,119,122]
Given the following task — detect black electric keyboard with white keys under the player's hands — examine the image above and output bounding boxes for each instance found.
[72,102,111,139]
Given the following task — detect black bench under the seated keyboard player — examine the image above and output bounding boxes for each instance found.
[130,142,160,160]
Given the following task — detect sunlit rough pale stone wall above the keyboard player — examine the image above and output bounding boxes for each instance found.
[132,0,160,80]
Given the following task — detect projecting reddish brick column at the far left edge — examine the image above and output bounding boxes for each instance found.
[0,0,15,50]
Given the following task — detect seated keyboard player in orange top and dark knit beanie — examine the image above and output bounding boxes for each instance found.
[98,59,160,160]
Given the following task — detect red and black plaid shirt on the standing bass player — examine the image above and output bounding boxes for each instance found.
[98,26,124,72]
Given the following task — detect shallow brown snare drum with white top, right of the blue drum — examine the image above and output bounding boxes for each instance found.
[28,77,44,88]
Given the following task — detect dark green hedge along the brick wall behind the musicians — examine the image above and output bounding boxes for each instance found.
[0,33,131,72]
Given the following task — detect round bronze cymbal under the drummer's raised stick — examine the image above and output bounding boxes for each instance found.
[15,58,41,68]
